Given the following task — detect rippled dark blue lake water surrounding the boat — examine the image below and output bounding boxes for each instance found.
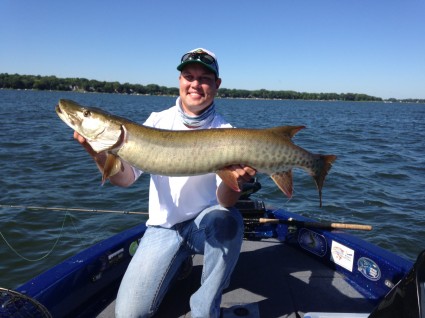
[0,90,425,288]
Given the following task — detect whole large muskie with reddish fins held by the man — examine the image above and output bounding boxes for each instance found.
[56,99,336,206]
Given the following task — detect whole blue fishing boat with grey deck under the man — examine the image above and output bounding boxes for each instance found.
[0,188,425,318]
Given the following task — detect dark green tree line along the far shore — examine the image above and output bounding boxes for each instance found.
[0,73,425,102]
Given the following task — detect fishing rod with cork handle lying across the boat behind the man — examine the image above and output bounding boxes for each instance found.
[0,204,372,231]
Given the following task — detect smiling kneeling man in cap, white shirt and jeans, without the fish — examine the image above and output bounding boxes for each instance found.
[74,48,255,318]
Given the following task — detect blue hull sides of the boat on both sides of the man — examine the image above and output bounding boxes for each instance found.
[12,210,412,317]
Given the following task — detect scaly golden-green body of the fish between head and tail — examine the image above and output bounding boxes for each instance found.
[117,124,304,176]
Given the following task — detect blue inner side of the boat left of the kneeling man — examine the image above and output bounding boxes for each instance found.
[17,225,146,317]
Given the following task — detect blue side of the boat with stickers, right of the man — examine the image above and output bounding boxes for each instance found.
[274,210,413,303]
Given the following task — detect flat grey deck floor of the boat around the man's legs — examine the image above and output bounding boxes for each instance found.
[98,239,374,318]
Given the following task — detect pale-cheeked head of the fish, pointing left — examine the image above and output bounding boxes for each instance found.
[56,99,125,152]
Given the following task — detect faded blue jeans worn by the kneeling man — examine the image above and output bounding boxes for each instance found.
[115,205,243,318]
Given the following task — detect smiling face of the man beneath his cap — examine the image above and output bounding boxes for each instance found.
[179,63,221,116]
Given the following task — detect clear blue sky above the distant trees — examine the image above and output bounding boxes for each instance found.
[0,0,425,98]
